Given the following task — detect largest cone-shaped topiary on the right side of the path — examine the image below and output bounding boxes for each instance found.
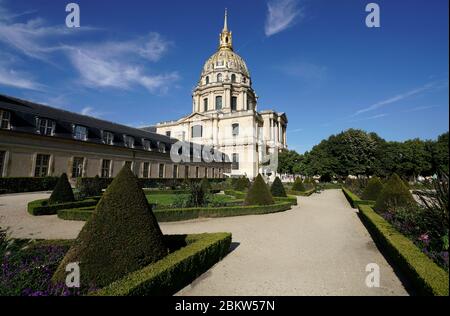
[374,173,415,212]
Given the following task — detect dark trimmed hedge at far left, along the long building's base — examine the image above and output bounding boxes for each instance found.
[0,177,59,194]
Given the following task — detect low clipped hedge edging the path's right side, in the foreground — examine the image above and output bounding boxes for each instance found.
[358,205,449,296]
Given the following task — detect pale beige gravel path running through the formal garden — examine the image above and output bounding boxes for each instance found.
[0,190,408,296]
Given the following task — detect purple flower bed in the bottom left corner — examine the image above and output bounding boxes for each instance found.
[0,241,95,296]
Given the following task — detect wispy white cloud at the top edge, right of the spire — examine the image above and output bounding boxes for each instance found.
[265,0,303,36]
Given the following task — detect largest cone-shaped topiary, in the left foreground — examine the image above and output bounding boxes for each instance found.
[52,166,168,288]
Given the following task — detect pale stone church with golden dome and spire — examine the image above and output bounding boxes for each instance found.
[155,9,288,178]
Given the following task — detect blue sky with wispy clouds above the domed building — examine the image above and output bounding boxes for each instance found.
[0,0,449,152]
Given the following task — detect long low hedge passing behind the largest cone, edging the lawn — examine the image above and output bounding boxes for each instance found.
[58,201,292,222]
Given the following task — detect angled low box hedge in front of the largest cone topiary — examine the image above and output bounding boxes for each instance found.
[90,233,231,296]
